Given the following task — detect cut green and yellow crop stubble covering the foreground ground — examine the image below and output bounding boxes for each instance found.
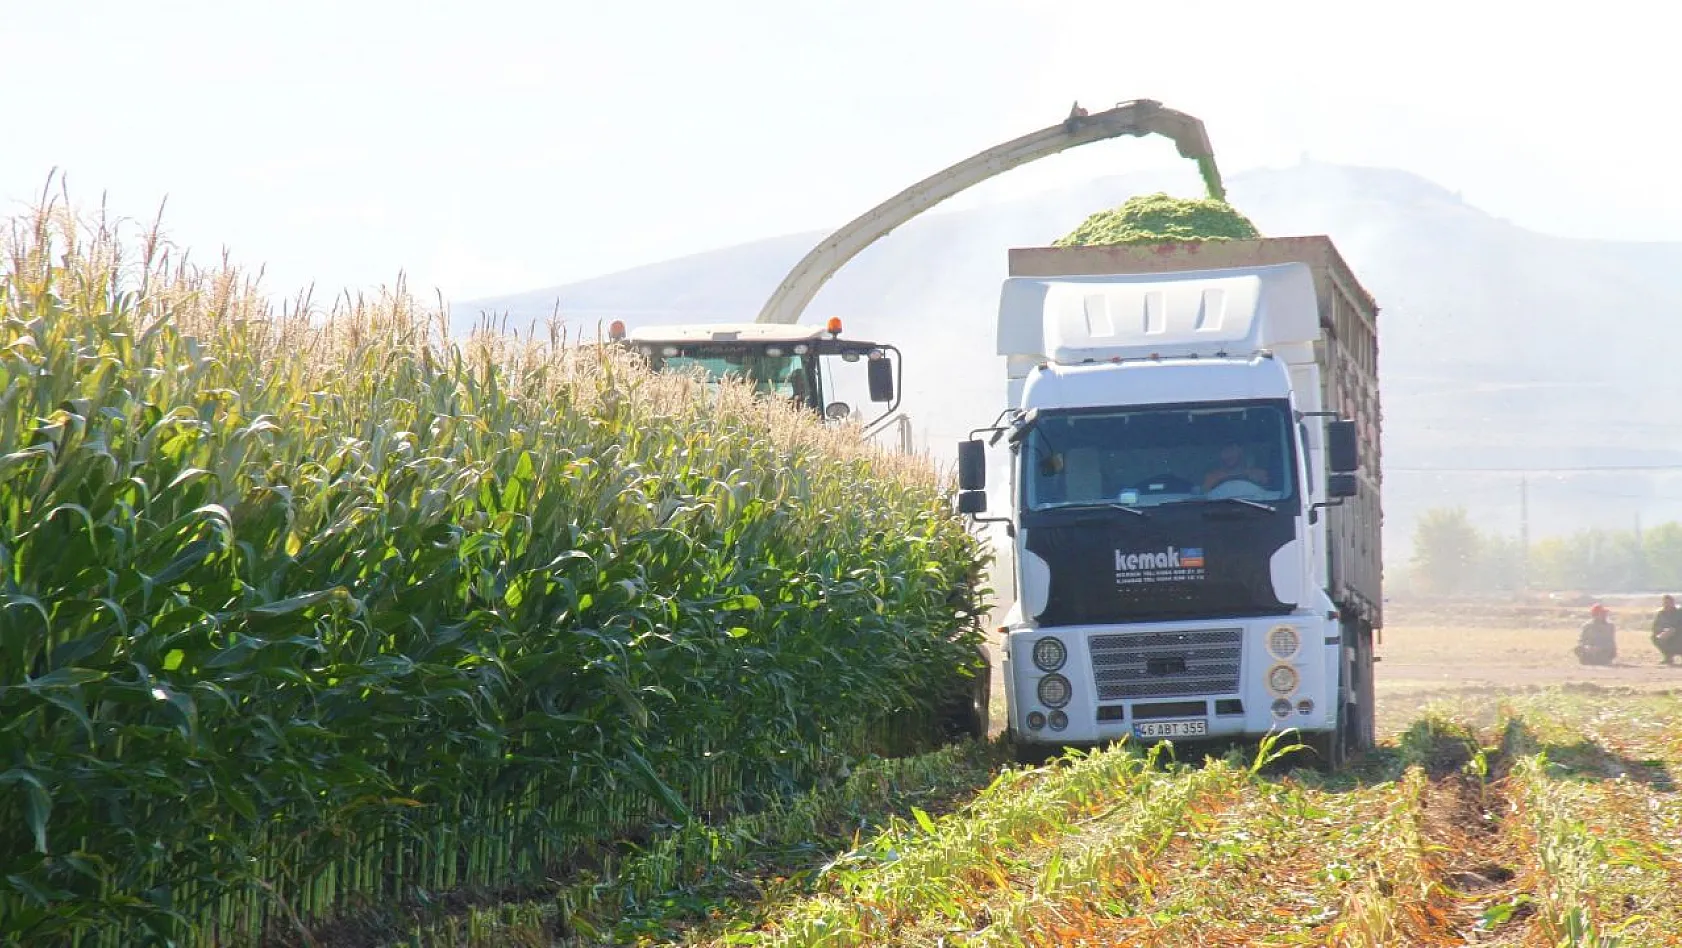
[642,689,1682,948]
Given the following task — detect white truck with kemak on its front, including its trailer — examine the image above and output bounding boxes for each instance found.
[959,237,1383,768]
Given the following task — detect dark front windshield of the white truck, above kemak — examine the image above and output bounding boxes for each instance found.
[1023,402,1295,509]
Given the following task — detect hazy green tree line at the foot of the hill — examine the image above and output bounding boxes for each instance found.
[1410,508,1682,595]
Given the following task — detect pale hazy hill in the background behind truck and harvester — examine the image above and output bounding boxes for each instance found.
[452,163,1682,561]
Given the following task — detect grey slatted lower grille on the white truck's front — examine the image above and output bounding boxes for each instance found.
[1087,629,1243,701]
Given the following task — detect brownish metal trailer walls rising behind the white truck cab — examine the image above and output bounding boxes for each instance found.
[1009,235,1384,629]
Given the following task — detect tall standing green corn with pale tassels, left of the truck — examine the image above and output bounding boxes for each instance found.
[0,202,984,946]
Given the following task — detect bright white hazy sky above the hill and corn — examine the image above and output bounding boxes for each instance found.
[0,0,1682,304]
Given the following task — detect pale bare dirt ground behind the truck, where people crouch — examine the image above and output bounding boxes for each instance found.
[992,602,1682,733]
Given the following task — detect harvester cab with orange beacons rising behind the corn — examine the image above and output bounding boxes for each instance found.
[609,319,903,430]
